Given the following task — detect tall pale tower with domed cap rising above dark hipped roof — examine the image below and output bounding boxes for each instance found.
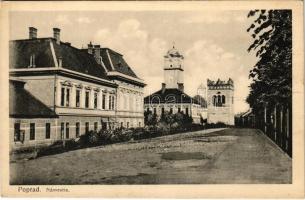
[164,46,184,90]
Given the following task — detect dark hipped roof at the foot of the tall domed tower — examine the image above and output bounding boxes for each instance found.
[144,88,199,104]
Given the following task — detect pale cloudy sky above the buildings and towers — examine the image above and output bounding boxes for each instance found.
[10,10,257,113]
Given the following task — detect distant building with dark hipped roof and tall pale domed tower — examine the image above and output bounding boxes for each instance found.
[144,46,206,123]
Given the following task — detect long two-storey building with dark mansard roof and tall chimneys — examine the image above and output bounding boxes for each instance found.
[9,27,145,148]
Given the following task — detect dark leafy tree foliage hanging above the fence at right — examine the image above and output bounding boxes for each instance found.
[247,10,292,112]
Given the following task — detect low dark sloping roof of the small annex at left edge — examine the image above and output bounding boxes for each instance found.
[9,80,57,118]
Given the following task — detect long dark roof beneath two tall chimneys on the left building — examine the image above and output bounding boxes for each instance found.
[10,38,109,80]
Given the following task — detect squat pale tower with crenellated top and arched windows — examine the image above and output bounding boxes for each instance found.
[207,78,234,125]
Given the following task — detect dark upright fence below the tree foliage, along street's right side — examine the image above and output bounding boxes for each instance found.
[236,104,292,157]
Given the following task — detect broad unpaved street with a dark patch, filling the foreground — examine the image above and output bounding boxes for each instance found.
[10,128,292,185]
